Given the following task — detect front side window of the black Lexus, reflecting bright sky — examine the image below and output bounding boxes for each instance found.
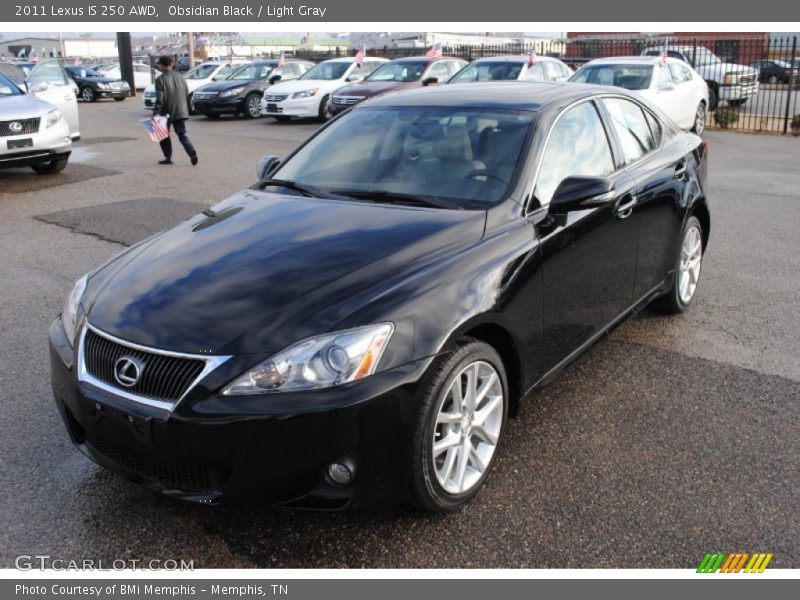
[534,102,614,206]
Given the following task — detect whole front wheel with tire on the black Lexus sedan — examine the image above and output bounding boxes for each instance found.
[411,340,508,512]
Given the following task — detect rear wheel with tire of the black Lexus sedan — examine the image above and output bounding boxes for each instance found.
[651,217,703,314]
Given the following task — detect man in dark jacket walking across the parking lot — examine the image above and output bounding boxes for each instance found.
[153,56,197,165]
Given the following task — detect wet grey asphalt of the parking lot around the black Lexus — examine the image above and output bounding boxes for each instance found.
[0,98,800,568]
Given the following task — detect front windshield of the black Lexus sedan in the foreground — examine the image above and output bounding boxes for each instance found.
[273,106,533,208]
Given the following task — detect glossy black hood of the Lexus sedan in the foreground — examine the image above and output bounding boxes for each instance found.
[82,191,485,355]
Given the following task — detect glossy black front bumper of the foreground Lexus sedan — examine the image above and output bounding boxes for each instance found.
[50,319,429,510]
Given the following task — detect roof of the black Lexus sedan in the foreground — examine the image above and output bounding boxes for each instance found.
[365,81,612,111]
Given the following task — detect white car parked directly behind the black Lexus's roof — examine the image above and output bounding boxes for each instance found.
[447,54,572,83]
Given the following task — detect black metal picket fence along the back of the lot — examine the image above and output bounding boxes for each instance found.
[270,33,800,135]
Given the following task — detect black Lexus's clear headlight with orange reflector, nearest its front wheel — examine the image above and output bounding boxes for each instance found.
[222,323,394,396]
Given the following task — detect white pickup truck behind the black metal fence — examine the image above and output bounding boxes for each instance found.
[642,44,758,110]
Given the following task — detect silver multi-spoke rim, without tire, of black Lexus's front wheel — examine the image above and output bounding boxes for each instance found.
[431,361,504,494]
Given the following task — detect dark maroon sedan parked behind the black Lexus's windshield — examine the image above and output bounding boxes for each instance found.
[327,56,467,115]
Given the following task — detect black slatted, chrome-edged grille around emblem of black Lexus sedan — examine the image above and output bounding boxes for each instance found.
[83,329,206,403]
